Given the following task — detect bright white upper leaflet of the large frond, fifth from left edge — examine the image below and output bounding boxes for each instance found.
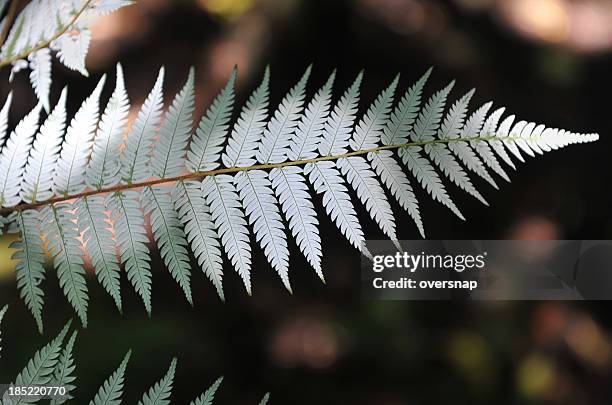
[86,64,130,190]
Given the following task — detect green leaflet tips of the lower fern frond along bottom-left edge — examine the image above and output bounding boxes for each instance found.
[0,306,270,405]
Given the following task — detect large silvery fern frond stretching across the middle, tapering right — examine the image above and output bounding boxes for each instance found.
[0,60,598,330]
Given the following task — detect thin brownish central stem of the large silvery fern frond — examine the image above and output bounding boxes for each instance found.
[0,136,521,215]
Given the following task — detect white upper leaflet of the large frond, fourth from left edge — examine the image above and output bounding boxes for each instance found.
[53,76,106,195]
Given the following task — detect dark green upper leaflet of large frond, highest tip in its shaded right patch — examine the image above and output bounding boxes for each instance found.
[382,69,431,145]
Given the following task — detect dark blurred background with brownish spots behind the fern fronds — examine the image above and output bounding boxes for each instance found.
[0,0,612,405]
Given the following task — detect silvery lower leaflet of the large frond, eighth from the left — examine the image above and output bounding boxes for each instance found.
[234,170,291,292]
